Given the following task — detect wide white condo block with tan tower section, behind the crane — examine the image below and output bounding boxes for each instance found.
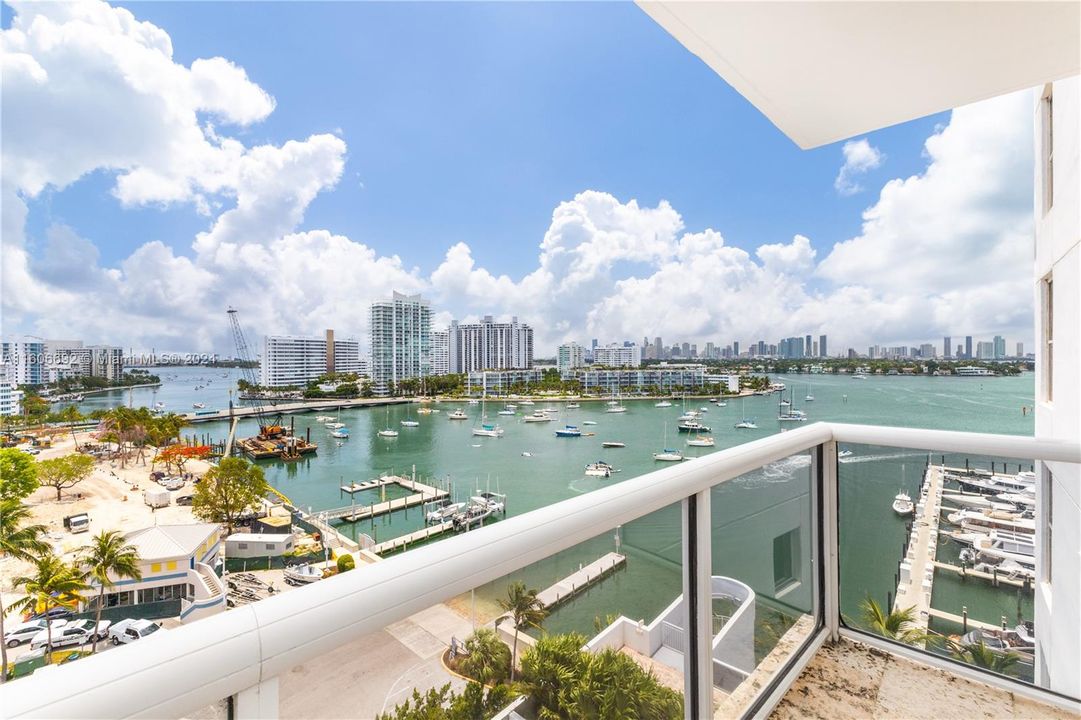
[259,330,363,387]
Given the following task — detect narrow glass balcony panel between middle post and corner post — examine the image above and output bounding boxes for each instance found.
[710,445,818,718]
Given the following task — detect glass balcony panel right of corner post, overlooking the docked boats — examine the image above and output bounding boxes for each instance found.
[838,444,1076,686]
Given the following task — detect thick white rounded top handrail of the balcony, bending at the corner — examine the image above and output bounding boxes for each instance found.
[0,423,1081,718]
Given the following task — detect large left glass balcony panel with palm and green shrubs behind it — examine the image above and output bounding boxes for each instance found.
[300,503,683,719]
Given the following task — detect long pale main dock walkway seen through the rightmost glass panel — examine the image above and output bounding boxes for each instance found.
[893,465,945,630]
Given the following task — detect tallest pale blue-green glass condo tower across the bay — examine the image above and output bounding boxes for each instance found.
[371,292,431,395]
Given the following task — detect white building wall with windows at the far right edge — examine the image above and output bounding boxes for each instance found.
[1033,77,1081,697]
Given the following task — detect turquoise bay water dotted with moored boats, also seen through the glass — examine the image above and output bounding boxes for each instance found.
[82,369,1033,634]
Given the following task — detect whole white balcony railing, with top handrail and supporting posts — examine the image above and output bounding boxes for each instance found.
[0,423,1081,718]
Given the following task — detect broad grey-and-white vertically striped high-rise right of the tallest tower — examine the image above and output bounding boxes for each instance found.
[448,315,533,373]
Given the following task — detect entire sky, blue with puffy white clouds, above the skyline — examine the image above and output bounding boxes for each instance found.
[0,0,1032,357]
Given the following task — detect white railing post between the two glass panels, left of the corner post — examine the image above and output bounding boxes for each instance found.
[682,490,713,720]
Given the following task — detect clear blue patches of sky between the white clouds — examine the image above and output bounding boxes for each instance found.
[3,2,1030,352]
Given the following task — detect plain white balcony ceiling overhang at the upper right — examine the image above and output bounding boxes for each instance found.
[638,0,1081,148]
